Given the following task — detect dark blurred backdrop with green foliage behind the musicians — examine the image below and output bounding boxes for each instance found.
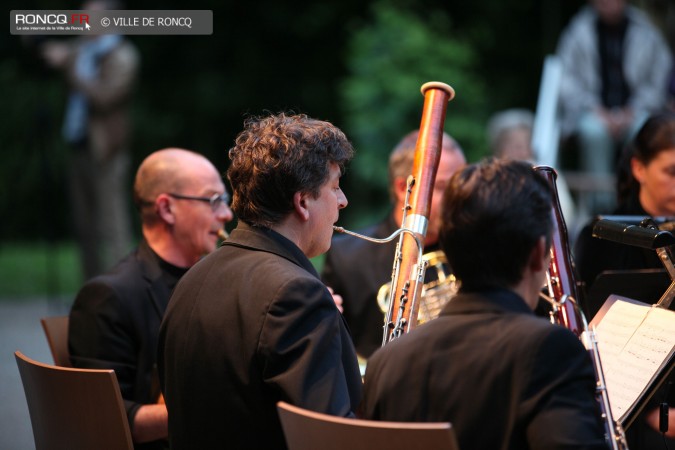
[0,0,584,296]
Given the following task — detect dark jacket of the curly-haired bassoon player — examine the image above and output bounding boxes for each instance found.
[158,221,361,450]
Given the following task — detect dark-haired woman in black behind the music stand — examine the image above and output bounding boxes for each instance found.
[575,112,675,448]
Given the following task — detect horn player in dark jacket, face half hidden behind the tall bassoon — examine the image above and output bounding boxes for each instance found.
[321,131,466,358]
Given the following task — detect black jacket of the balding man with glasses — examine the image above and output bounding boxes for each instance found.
[68,241,185,448]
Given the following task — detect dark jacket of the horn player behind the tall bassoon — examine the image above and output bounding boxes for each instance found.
[321,215,399,358]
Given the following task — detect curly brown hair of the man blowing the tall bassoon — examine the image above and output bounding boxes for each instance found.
[227,113,354,228]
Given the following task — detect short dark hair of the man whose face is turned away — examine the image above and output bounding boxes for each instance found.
[440,158,553,290]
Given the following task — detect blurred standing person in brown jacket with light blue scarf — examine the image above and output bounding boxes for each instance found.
[41,0,140,279]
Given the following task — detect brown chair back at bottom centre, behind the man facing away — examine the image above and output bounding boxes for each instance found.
[277,402,459,450]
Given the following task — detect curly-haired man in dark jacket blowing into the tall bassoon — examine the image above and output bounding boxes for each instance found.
[158,113,362,450]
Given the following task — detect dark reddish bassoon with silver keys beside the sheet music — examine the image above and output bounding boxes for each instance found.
[534,166,628,450]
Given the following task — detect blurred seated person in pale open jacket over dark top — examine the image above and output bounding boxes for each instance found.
[557,0,672,212]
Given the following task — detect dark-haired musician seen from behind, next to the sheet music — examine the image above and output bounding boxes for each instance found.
[359,160,607,450]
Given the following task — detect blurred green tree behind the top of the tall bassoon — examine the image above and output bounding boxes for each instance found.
[339,1,486,222]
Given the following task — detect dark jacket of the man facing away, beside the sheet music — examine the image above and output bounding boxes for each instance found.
[362,291,607,450]
